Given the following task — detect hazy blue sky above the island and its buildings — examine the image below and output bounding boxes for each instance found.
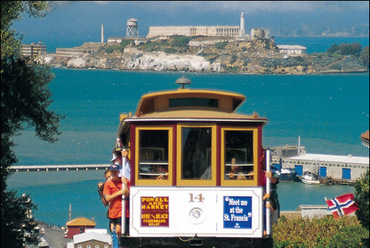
[13,1,369,50]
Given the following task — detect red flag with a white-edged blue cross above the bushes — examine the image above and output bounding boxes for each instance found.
[325,194,358,218]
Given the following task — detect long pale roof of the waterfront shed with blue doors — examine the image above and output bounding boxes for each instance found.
[285,153,369,165]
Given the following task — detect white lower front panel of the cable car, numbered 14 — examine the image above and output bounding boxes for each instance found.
[130,187,264,238]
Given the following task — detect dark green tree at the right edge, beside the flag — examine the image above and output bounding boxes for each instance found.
[355,171,370,230]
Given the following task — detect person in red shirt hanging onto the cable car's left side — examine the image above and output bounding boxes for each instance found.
[103,164,130,244]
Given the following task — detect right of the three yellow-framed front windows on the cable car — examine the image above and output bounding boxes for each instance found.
[224,130,254,180]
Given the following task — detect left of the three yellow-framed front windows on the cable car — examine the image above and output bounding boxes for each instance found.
[139,130,169,180]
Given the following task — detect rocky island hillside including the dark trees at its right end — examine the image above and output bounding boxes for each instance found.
[40,36,369,74]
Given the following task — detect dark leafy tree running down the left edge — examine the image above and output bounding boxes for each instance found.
[1,1,63,247]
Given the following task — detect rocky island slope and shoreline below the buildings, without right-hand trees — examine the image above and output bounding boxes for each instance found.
[37,39,368,74]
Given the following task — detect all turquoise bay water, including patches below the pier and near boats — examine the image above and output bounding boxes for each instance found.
[7,35,369,228]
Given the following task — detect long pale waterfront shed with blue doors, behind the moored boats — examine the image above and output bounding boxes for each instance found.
[270,144,369,183]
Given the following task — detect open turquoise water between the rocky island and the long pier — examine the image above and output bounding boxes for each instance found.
[15,69,369,165]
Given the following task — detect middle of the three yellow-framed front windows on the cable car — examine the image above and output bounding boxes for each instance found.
[181,127,212,180]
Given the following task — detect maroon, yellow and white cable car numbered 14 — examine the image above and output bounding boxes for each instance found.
[114,78,272,247]
